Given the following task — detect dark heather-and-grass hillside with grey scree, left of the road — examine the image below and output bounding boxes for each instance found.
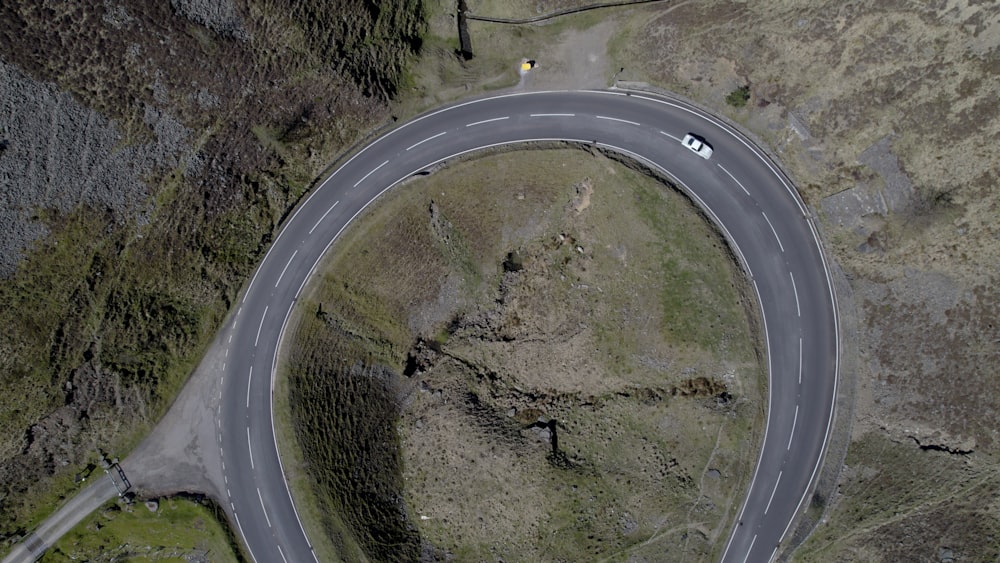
[0,0,423,548]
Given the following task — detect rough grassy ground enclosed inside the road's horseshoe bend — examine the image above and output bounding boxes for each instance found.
[278,150,764,561]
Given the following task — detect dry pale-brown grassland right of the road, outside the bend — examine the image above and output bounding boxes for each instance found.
[613,0,1000,560]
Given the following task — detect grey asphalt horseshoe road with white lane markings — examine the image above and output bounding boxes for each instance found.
[217,91,839,562]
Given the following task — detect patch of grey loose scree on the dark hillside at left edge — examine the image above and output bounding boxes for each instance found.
[0,61,190,278]
